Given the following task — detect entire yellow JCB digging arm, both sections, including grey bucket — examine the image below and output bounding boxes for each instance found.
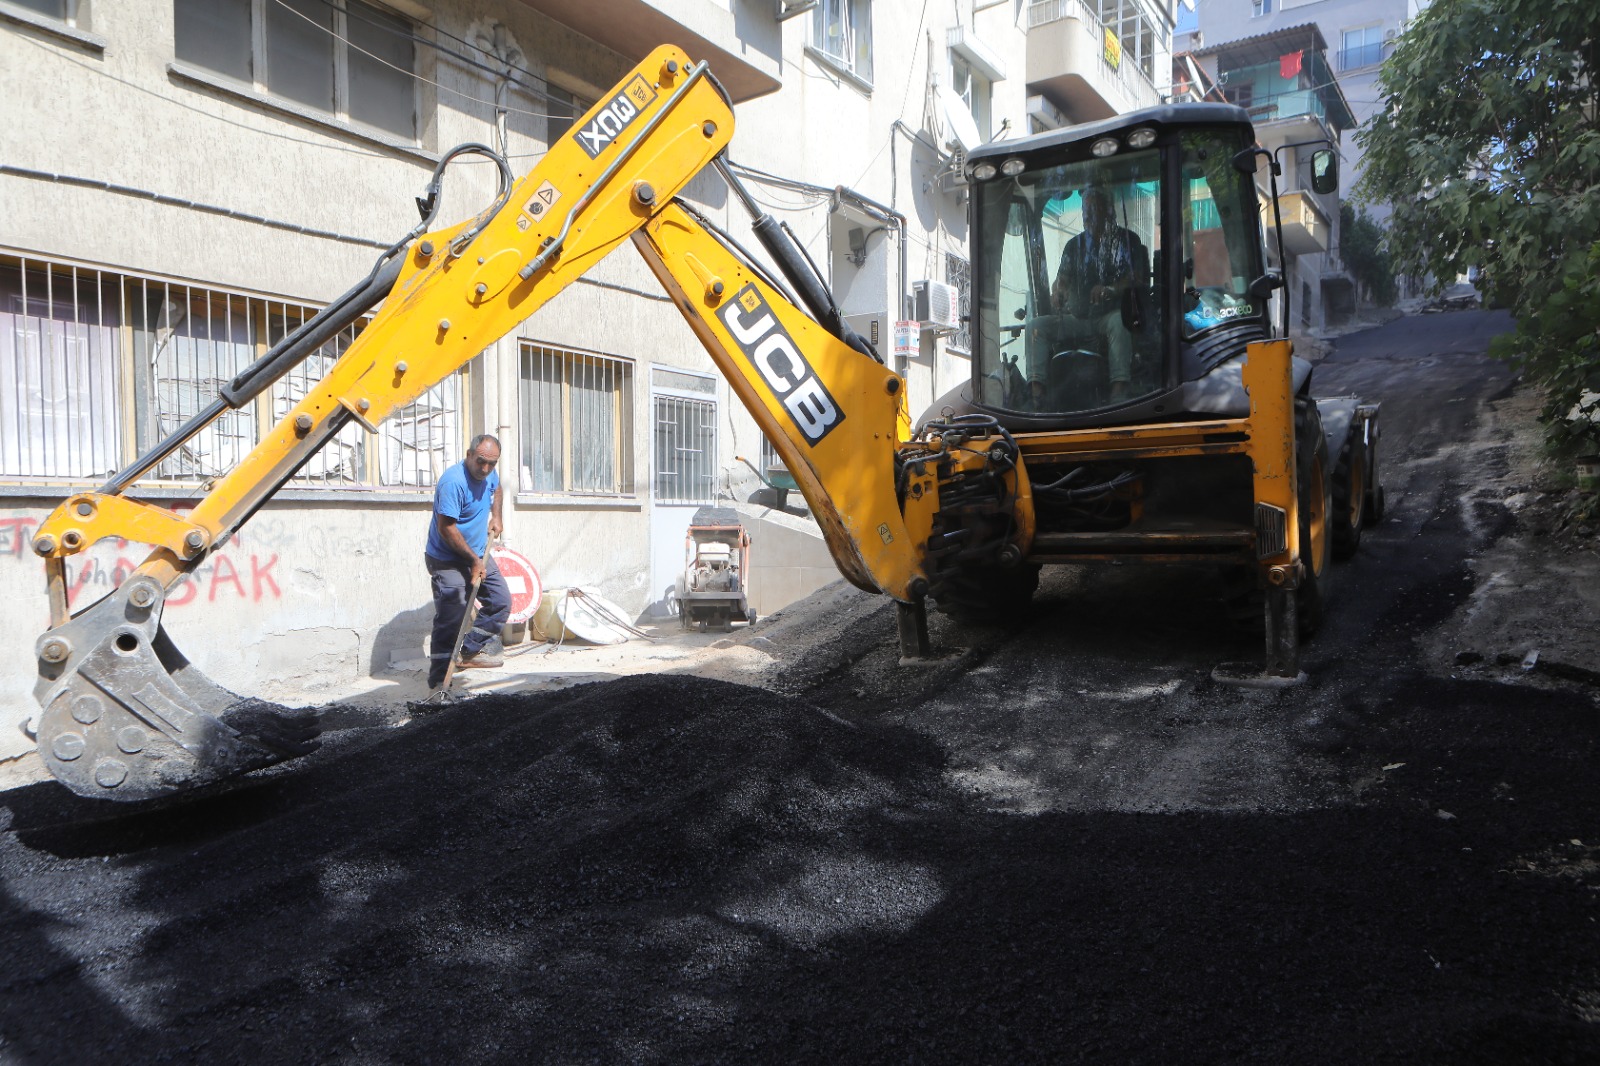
[34,46,949,800]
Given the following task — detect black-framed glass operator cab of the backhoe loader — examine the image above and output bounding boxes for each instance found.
[963,104,1275,429]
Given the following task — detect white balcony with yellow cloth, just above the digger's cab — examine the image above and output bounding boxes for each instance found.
[1027,0,1162,122]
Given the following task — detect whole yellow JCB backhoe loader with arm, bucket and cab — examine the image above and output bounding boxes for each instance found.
[34,46,1374,800]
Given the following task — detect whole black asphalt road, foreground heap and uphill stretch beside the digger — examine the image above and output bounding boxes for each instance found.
[0,305,1600,1063]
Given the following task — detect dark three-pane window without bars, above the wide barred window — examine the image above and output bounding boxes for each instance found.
[173,0,418,141]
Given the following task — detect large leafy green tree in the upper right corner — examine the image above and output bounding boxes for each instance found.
[1357,0,1600,448]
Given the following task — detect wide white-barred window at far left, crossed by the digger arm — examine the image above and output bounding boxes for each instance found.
[0,254,462,488]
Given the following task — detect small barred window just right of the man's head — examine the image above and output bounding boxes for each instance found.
[518,341,634,496]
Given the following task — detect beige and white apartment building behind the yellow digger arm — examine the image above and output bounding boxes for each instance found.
[0,0,1027,739]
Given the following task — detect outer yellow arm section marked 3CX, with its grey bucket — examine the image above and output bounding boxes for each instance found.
[34,46,733,800]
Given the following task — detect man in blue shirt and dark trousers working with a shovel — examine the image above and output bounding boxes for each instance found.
[426,434,510,688]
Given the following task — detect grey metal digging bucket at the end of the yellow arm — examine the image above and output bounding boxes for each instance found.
[35,578,322,802]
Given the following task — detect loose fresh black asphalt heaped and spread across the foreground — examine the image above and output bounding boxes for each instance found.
[0,665,1600,1063]
